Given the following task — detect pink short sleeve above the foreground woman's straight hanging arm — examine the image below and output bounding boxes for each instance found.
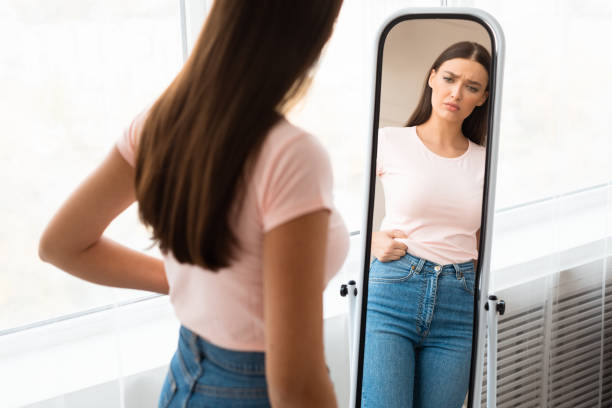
[257,133,333,232]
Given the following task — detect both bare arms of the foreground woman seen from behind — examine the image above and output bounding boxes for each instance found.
[39,148,337,407]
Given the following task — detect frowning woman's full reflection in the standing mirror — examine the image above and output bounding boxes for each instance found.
[362,42,491,408]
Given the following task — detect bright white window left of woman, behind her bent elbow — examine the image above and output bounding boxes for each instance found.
[0,0,182,331]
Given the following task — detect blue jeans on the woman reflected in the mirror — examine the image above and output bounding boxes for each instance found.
[361,254,475,408]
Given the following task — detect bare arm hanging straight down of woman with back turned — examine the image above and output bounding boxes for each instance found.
[263,210,337,408]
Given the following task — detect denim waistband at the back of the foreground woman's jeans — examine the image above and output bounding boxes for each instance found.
[180,325,265,375]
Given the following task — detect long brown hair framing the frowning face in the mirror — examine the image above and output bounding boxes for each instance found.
[406,41,491,145]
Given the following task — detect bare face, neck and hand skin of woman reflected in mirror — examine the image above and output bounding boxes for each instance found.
[372,58,489,267]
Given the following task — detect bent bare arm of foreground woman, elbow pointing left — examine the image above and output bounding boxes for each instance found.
[38,147,168,294]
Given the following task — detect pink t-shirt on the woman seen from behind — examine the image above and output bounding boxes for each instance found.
[117,114,349,351]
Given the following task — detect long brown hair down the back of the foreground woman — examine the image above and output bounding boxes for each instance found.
[135,0,342,271]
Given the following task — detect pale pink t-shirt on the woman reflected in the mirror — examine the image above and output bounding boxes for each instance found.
[376,127,486,265]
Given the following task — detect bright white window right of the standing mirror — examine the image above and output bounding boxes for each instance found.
[464,0,612,208]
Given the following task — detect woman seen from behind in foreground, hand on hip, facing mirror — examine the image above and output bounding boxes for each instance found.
[39,0,348,407]
